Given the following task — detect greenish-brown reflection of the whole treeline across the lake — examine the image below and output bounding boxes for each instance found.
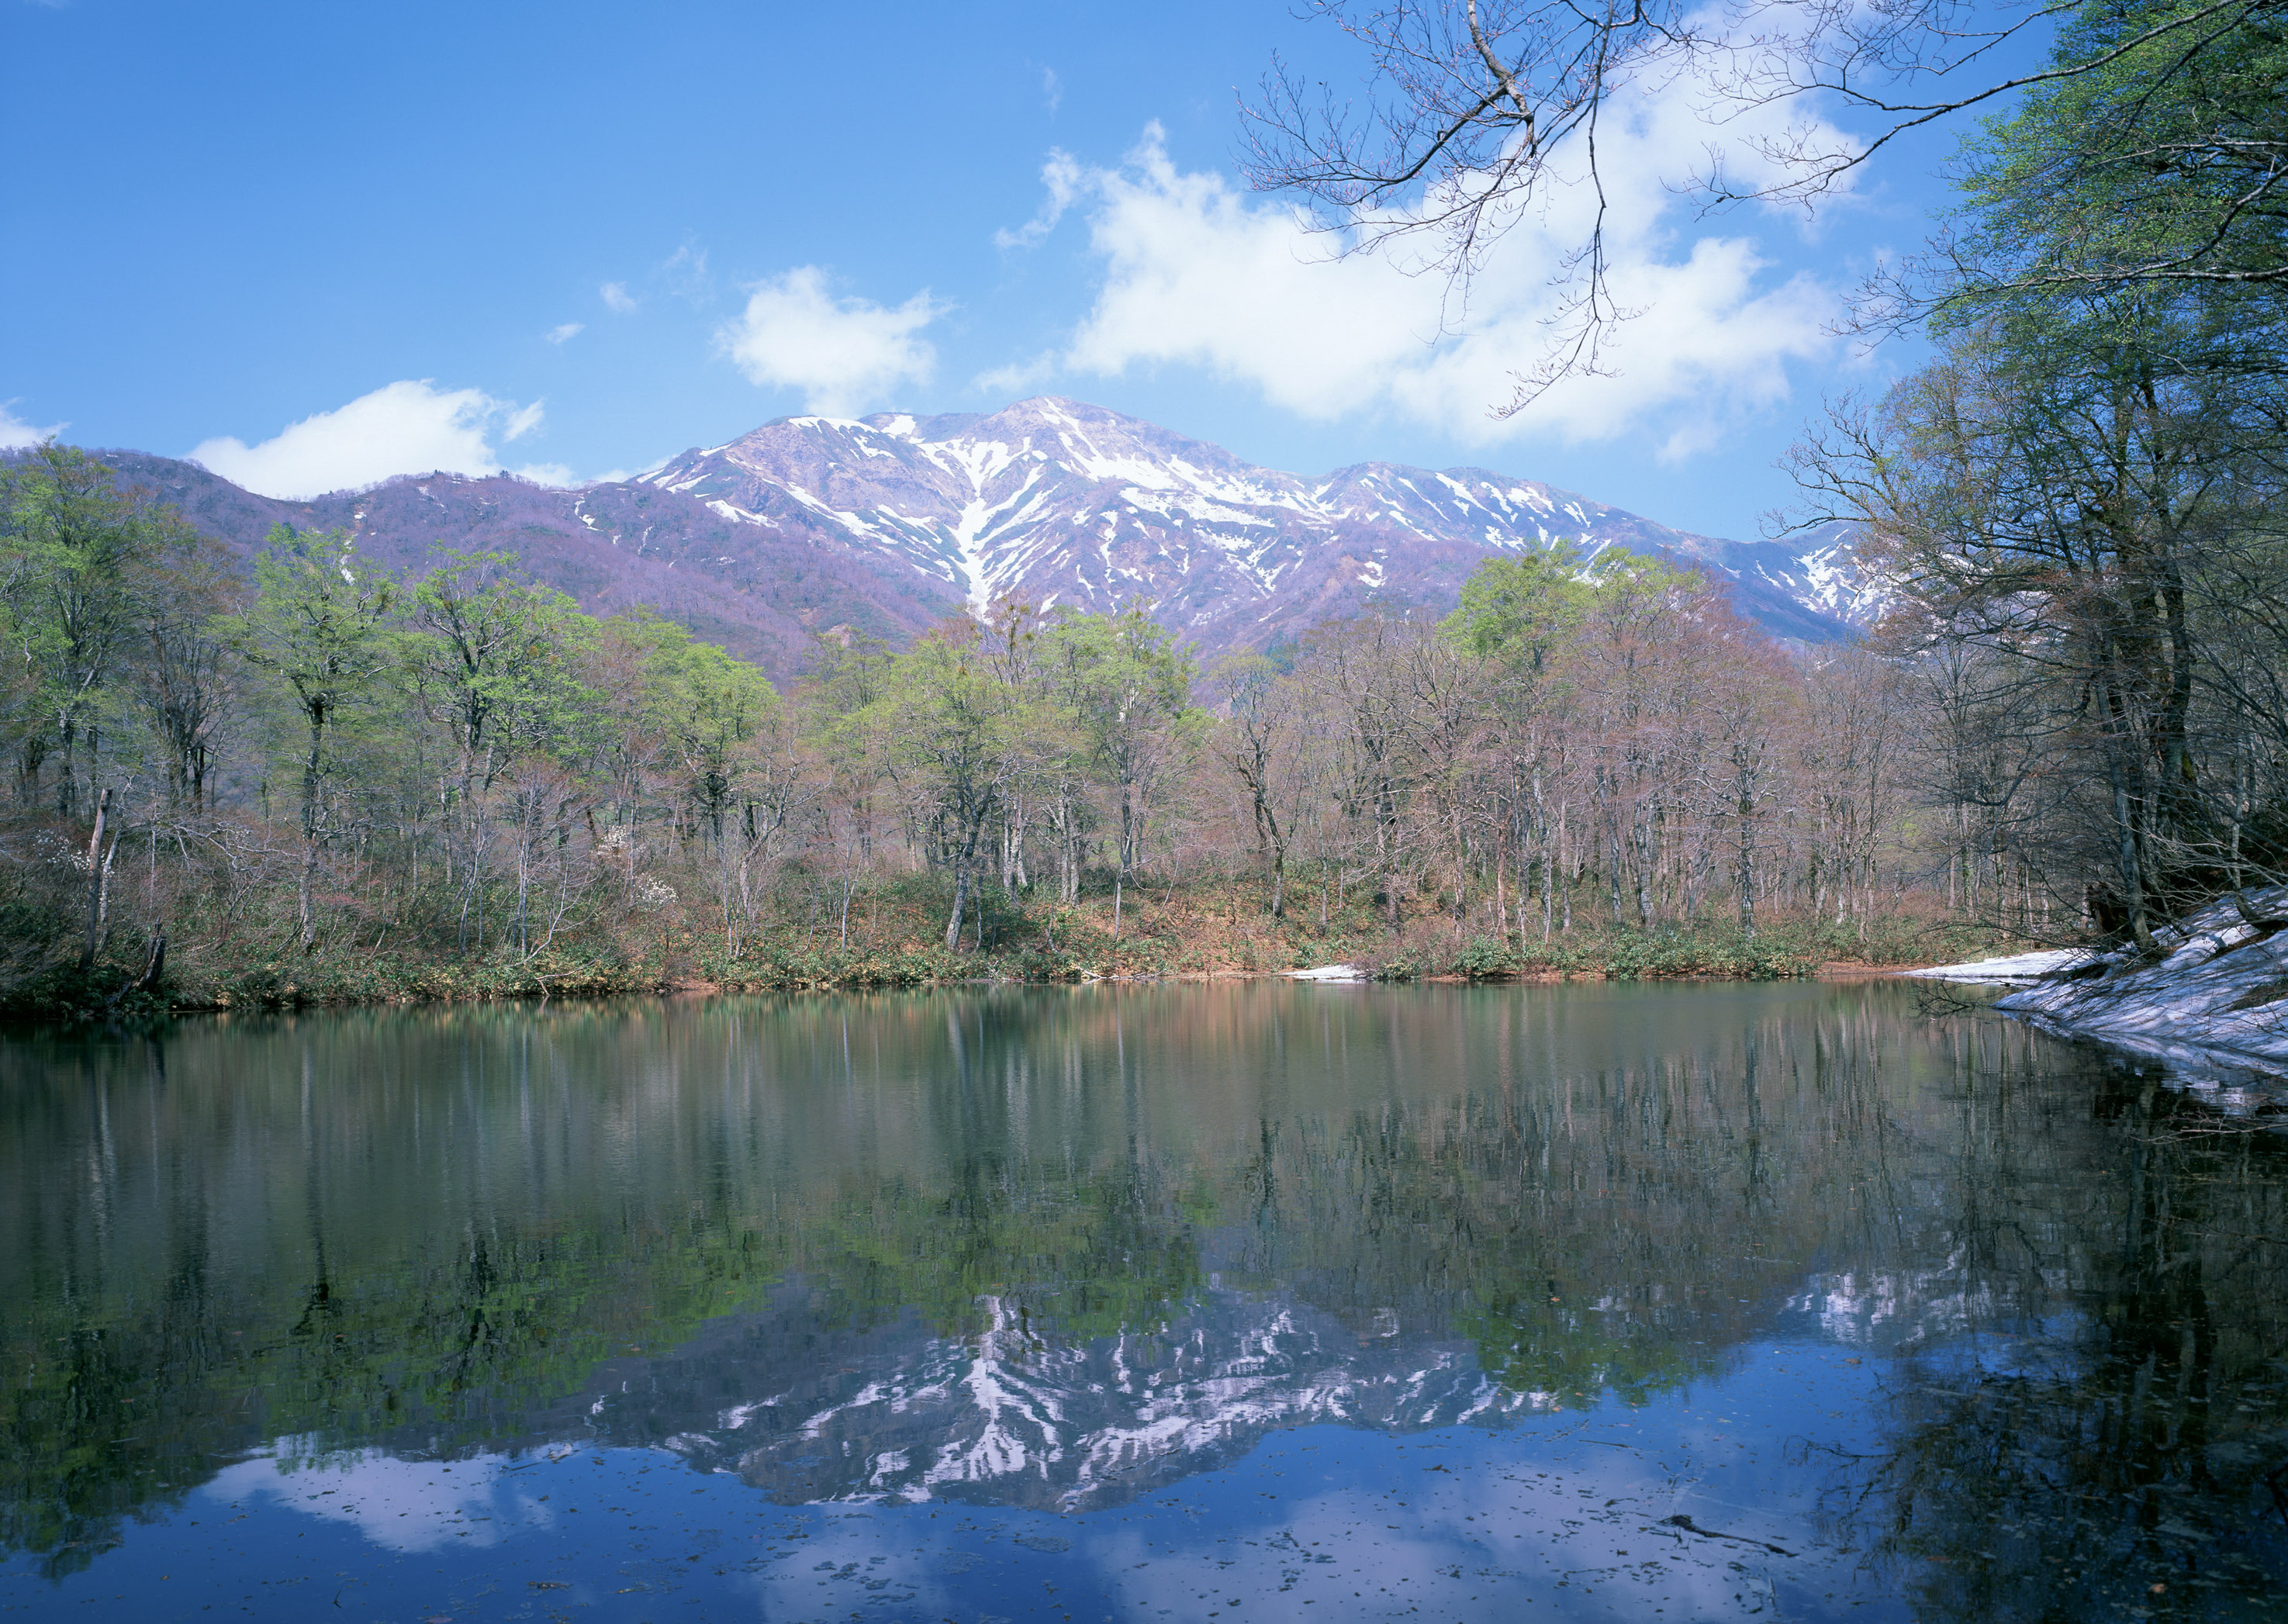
[0,986,2288,1608]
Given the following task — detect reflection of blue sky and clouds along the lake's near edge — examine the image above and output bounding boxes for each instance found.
[0,1342,1906,1624]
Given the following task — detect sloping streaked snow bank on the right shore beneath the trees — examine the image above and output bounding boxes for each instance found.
[1992,885,2288,1080]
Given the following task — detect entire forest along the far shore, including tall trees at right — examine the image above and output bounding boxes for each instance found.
[0,5,2288,1014]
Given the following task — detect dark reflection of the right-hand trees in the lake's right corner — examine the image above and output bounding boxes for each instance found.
[1830,1043,2288,1619]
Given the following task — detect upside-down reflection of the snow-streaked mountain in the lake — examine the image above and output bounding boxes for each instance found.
[556,1281,1556,1512]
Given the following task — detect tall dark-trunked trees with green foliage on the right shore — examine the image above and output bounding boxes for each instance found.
[1794,0,2288,945]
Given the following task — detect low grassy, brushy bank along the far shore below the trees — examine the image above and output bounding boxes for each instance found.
[5,876,2023,1022]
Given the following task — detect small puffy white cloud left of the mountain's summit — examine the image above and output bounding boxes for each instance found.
[716,265,945,416]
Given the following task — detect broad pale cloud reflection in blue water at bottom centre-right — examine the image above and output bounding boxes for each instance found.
[695,1450,1833,1624]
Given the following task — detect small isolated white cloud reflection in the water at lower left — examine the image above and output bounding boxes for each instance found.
[199,1439,556,1551]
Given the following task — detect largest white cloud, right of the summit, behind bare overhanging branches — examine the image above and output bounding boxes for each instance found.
[1002,89,1842,458]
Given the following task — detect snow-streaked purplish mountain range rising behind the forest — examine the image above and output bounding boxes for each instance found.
[76,396,1883,677]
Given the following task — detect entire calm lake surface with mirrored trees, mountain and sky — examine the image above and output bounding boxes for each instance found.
[0,981,2288,1624]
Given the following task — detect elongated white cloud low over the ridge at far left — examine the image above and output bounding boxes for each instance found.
[190,380,540,499]
